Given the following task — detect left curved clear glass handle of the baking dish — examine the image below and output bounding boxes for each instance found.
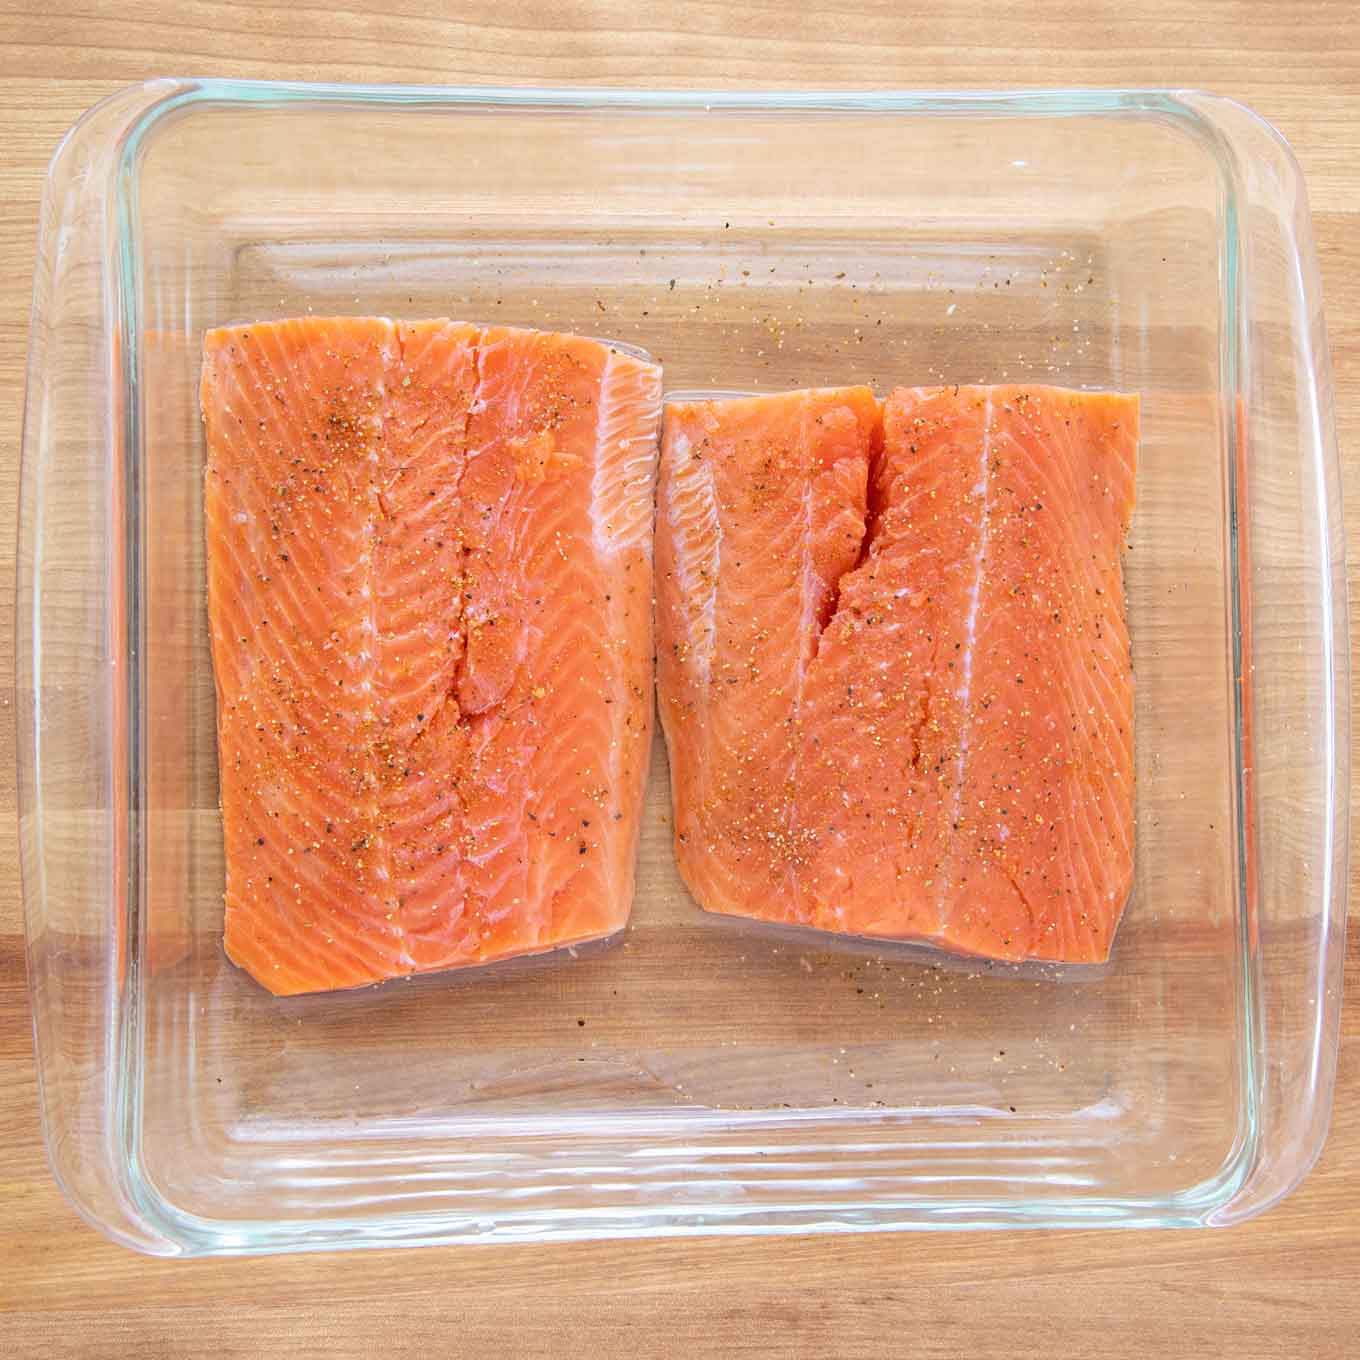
[15,80,194,1253]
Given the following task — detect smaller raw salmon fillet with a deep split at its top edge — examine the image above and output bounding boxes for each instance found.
[656,386,1138,962]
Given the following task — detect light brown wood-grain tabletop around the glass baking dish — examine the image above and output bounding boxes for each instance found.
[0,0,1360,1360]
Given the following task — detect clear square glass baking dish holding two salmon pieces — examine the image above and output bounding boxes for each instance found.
[18,80,1349,1255]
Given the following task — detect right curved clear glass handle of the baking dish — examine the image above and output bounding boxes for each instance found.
[1183,95,1350,1223]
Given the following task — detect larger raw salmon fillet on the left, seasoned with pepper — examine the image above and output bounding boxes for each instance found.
[201,318,661,994]
